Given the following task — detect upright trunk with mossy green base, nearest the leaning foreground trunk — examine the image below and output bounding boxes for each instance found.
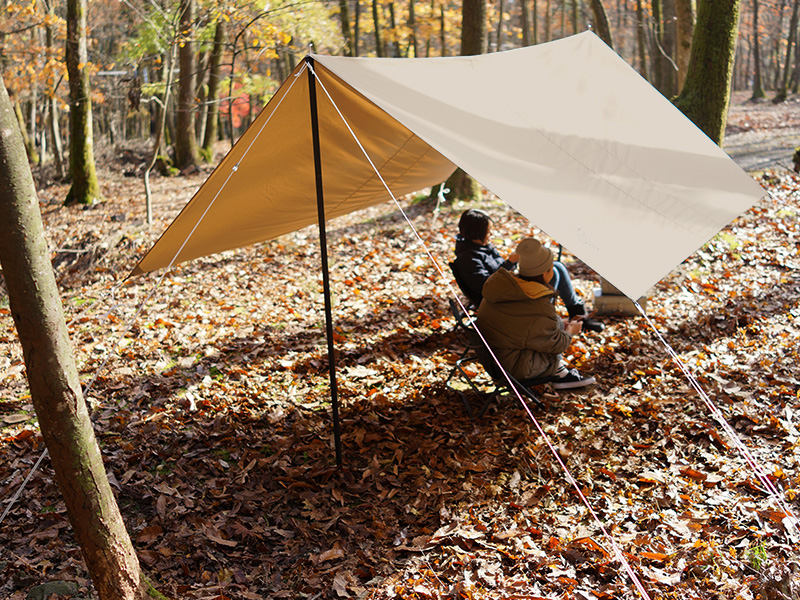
[64,0,100,204]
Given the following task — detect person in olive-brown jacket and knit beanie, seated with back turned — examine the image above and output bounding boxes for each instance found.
[477,238,595,389]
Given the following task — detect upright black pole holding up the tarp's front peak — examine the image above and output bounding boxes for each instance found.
[306,57,342,469]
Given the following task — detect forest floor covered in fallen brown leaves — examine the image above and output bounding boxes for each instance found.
[0,94,800,600]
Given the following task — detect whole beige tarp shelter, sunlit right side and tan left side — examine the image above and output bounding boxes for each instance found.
[134,33,763,298]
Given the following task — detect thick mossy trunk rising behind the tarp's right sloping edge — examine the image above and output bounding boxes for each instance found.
[675,0,741,146]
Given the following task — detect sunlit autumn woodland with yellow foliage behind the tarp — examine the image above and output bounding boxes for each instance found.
[0,0,800,171]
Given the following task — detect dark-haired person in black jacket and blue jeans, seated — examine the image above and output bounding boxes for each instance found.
[453,208,605,331]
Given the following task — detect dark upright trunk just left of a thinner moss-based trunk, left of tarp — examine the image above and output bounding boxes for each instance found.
[175,0,200,171]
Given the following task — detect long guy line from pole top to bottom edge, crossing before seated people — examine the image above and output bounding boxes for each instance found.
[309,62,650,600]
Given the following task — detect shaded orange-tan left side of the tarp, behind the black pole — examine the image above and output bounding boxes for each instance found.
[132,63,454,275]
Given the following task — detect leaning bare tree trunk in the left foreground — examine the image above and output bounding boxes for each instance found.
[0,71,148,600]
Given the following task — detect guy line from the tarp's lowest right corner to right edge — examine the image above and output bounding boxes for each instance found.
[634,302,800,544]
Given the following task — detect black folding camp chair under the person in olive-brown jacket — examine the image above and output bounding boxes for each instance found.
[445,298,553,419]
